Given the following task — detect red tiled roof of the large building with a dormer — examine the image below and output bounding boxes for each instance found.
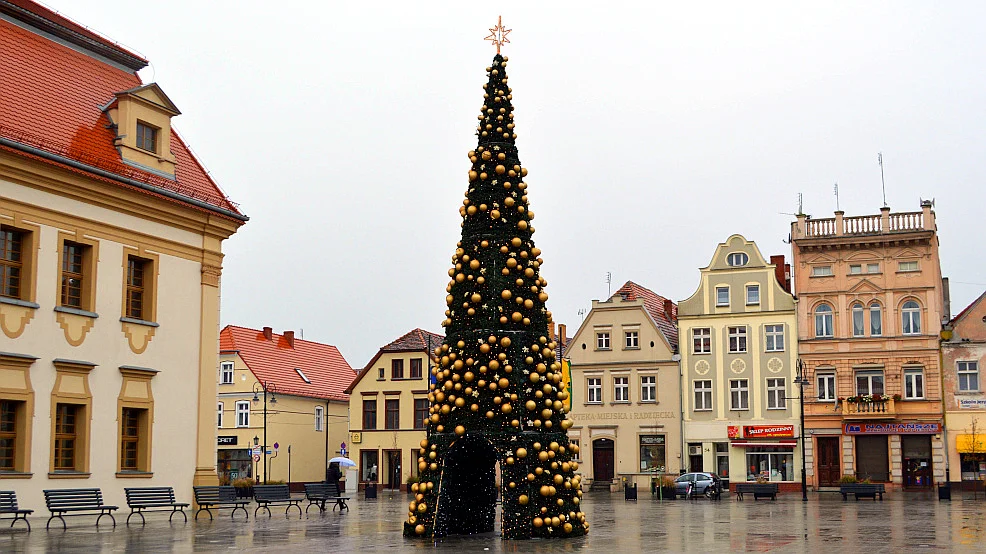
[0,10,242,219]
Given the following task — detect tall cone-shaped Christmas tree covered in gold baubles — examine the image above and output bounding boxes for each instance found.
[404,54,589,539]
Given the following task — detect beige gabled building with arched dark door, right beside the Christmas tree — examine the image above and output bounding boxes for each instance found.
[566,281,681,490]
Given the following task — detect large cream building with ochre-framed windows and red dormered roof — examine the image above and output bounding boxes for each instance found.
[0,2,247,507]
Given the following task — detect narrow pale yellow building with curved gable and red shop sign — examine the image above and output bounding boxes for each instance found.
[678,235,801,489]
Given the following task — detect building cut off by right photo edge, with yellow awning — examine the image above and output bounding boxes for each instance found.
[941,293,986,490]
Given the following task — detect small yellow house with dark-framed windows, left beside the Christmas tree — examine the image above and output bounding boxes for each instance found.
[346,329,445,489]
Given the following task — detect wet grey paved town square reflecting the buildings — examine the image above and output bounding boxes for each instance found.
[0,492,986,554]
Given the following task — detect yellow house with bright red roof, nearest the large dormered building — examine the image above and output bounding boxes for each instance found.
[216,325,356,490]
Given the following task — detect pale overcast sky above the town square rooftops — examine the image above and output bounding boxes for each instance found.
[55,0,986,368]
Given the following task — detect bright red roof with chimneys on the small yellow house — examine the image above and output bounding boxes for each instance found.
[219,325,356,402]
